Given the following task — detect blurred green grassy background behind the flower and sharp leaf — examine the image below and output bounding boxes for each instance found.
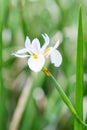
[0,0,87,130]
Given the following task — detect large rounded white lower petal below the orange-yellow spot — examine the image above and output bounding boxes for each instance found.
[28,55,45,72]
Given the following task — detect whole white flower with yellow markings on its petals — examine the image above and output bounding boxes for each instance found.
[12,34,62,72]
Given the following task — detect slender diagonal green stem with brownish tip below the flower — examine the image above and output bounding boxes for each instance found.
[42,67,87,127]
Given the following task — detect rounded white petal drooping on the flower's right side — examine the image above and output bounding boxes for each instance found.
[50,49,62,67]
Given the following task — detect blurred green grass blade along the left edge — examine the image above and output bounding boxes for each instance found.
[0,0,8,130]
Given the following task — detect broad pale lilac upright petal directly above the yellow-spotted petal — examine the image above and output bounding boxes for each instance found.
[31,38,40,54]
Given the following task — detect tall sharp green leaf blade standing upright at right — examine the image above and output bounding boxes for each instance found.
[74,7,84,130]
